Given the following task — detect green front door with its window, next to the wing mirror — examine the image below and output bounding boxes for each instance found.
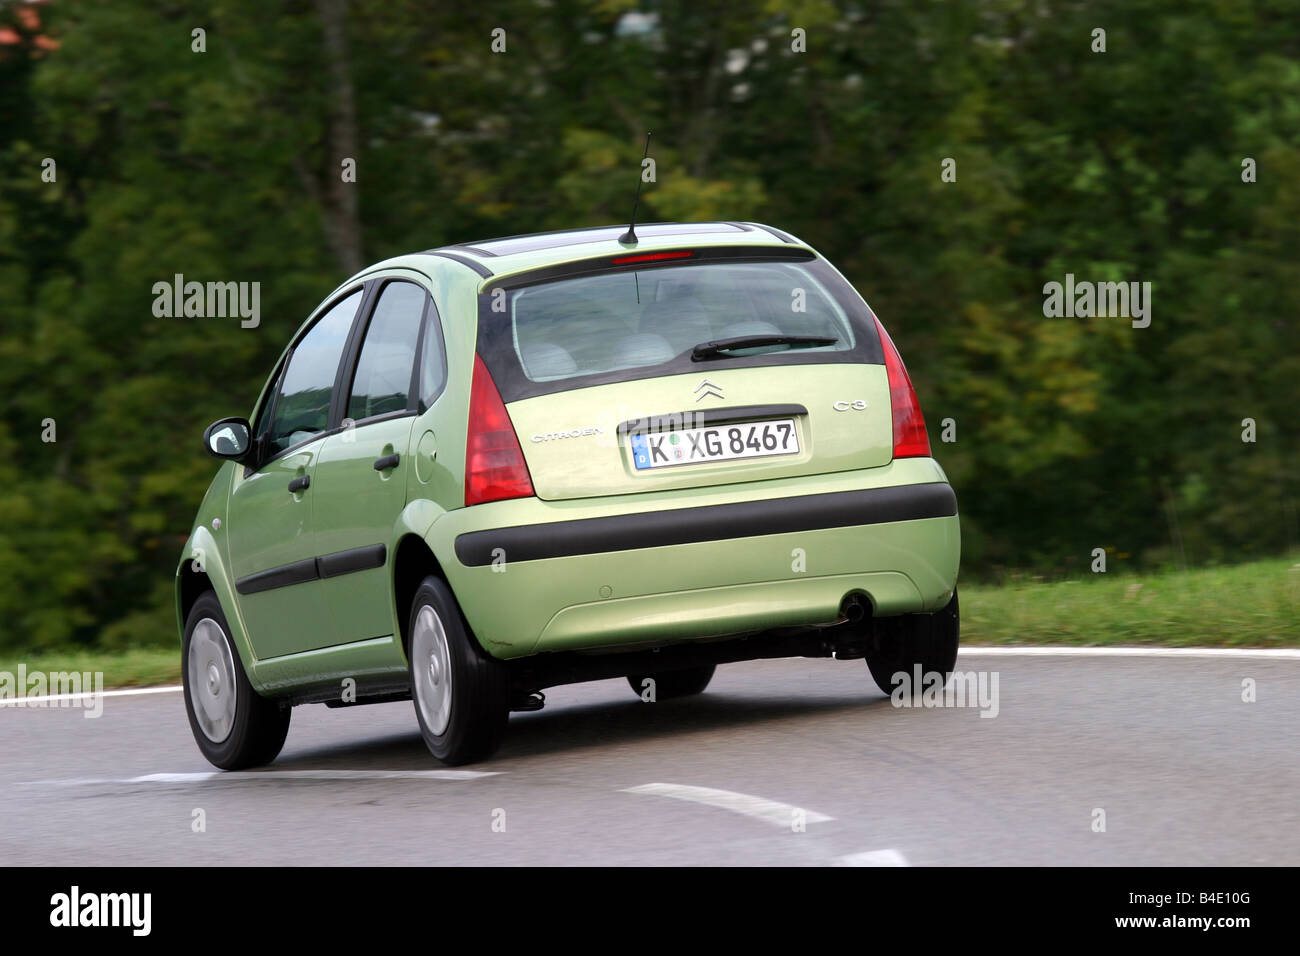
[226,287,363,659]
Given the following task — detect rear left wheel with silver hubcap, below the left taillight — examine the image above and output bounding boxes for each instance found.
[407,576,510,766]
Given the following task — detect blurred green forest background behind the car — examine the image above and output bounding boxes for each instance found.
[0,0,1300,649]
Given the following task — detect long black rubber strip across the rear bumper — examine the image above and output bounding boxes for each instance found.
[455,481,957,567]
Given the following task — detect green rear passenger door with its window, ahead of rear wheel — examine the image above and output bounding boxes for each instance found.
[315,277,445,643]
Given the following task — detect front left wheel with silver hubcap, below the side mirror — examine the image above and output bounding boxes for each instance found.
[181,591,291,770]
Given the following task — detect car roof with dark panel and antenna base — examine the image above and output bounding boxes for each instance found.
[421,222,806,280]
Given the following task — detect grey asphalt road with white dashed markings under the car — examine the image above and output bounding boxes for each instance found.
[0,652,1300,865]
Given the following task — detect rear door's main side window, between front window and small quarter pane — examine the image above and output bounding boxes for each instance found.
[347,282,425,421]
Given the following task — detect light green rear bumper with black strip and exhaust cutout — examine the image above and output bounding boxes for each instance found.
[430,459,961,658]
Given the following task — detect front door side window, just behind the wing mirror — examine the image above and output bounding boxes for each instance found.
[268,289,361,455]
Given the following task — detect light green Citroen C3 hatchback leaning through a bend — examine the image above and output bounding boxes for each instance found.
[176,222,959,769]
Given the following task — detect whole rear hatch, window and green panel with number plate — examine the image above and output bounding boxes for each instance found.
[478,246,893,499]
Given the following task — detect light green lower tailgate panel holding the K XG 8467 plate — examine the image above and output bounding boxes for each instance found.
[507,363,893,499]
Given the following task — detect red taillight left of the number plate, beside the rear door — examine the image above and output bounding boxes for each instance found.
[465,355,533,505]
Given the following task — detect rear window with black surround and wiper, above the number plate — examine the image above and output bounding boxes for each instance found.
[480,252,881,401]
